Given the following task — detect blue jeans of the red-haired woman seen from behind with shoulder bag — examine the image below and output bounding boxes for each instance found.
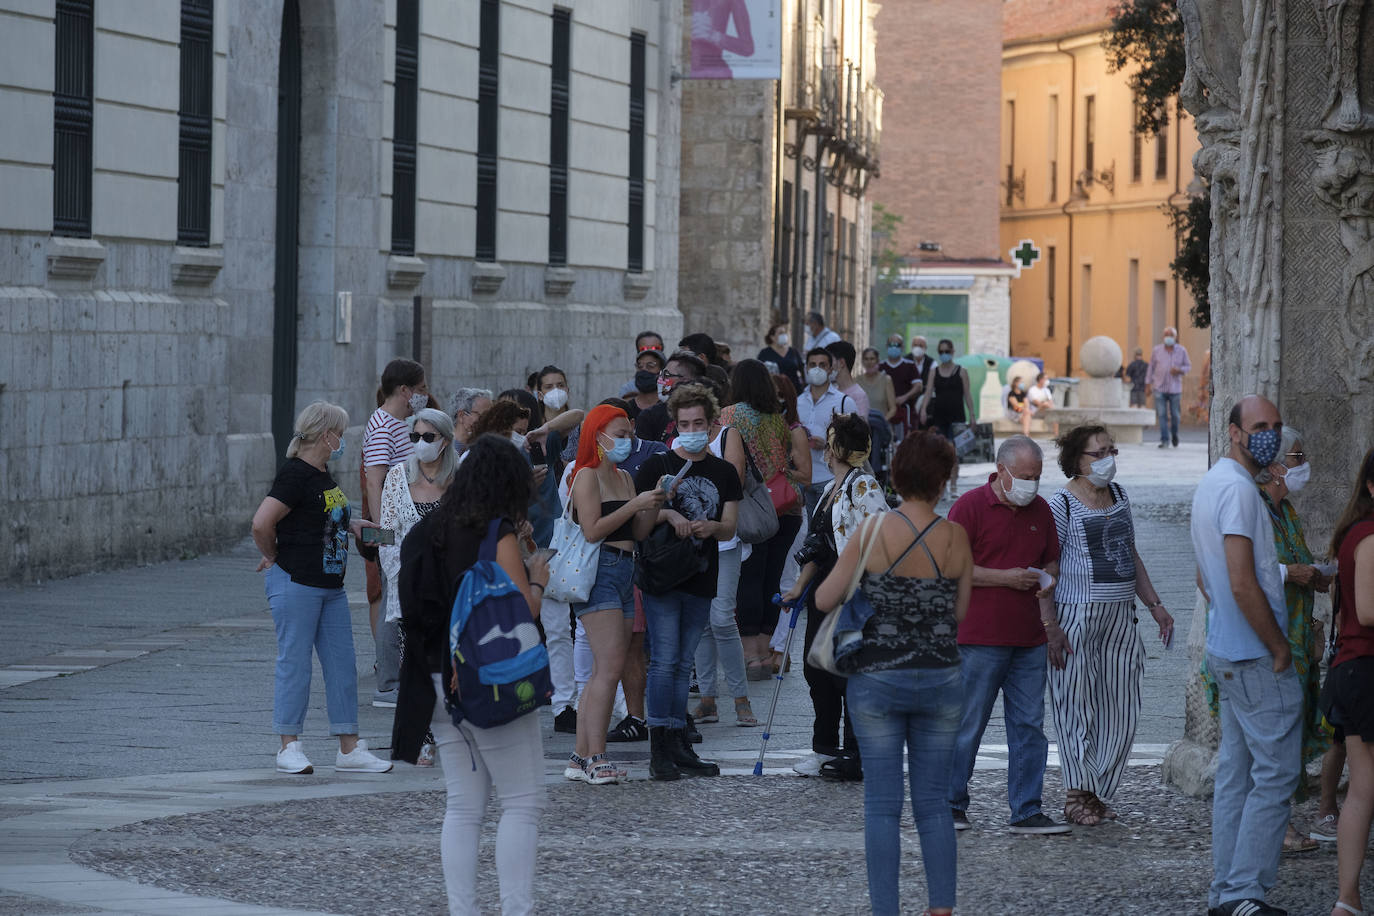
[845,665,963,916]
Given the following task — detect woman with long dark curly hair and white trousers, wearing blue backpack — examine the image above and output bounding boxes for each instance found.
[392,433,548,913]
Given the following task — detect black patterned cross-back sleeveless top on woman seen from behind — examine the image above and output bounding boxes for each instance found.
[845,512,959,674]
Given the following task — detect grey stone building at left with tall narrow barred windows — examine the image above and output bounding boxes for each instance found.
[0,0,682,580]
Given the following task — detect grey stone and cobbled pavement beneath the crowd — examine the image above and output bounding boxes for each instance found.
[0,431,1363,916]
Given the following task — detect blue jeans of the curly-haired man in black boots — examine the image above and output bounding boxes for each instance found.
[644,592,710,728]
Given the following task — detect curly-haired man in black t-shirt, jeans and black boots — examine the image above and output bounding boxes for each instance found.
[633,385,743,780]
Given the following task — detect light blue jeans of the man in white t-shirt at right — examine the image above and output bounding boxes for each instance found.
[1206,654,1303,906]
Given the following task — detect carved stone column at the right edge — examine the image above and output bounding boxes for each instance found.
[1164,0,1374,794]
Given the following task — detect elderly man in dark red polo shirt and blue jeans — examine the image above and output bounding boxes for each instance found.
[949,435,1070,834]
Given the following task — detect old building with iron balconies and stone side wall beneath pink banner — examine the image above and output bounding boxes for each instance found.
[677,0,882,357]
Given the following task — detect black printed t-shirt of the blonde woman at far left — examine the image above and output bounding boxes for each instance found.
[268,459,349,588]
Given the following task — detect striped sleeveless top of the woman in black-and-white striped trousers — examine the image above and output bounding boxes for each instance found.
[1050,483,1135,604]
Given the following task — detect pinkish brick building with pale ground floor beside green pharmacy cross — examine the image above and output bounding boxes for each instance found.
[871,0,1014,356]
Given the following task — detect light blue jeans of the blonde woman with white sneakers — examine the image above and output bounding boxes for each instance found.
[262,564,357,735]
